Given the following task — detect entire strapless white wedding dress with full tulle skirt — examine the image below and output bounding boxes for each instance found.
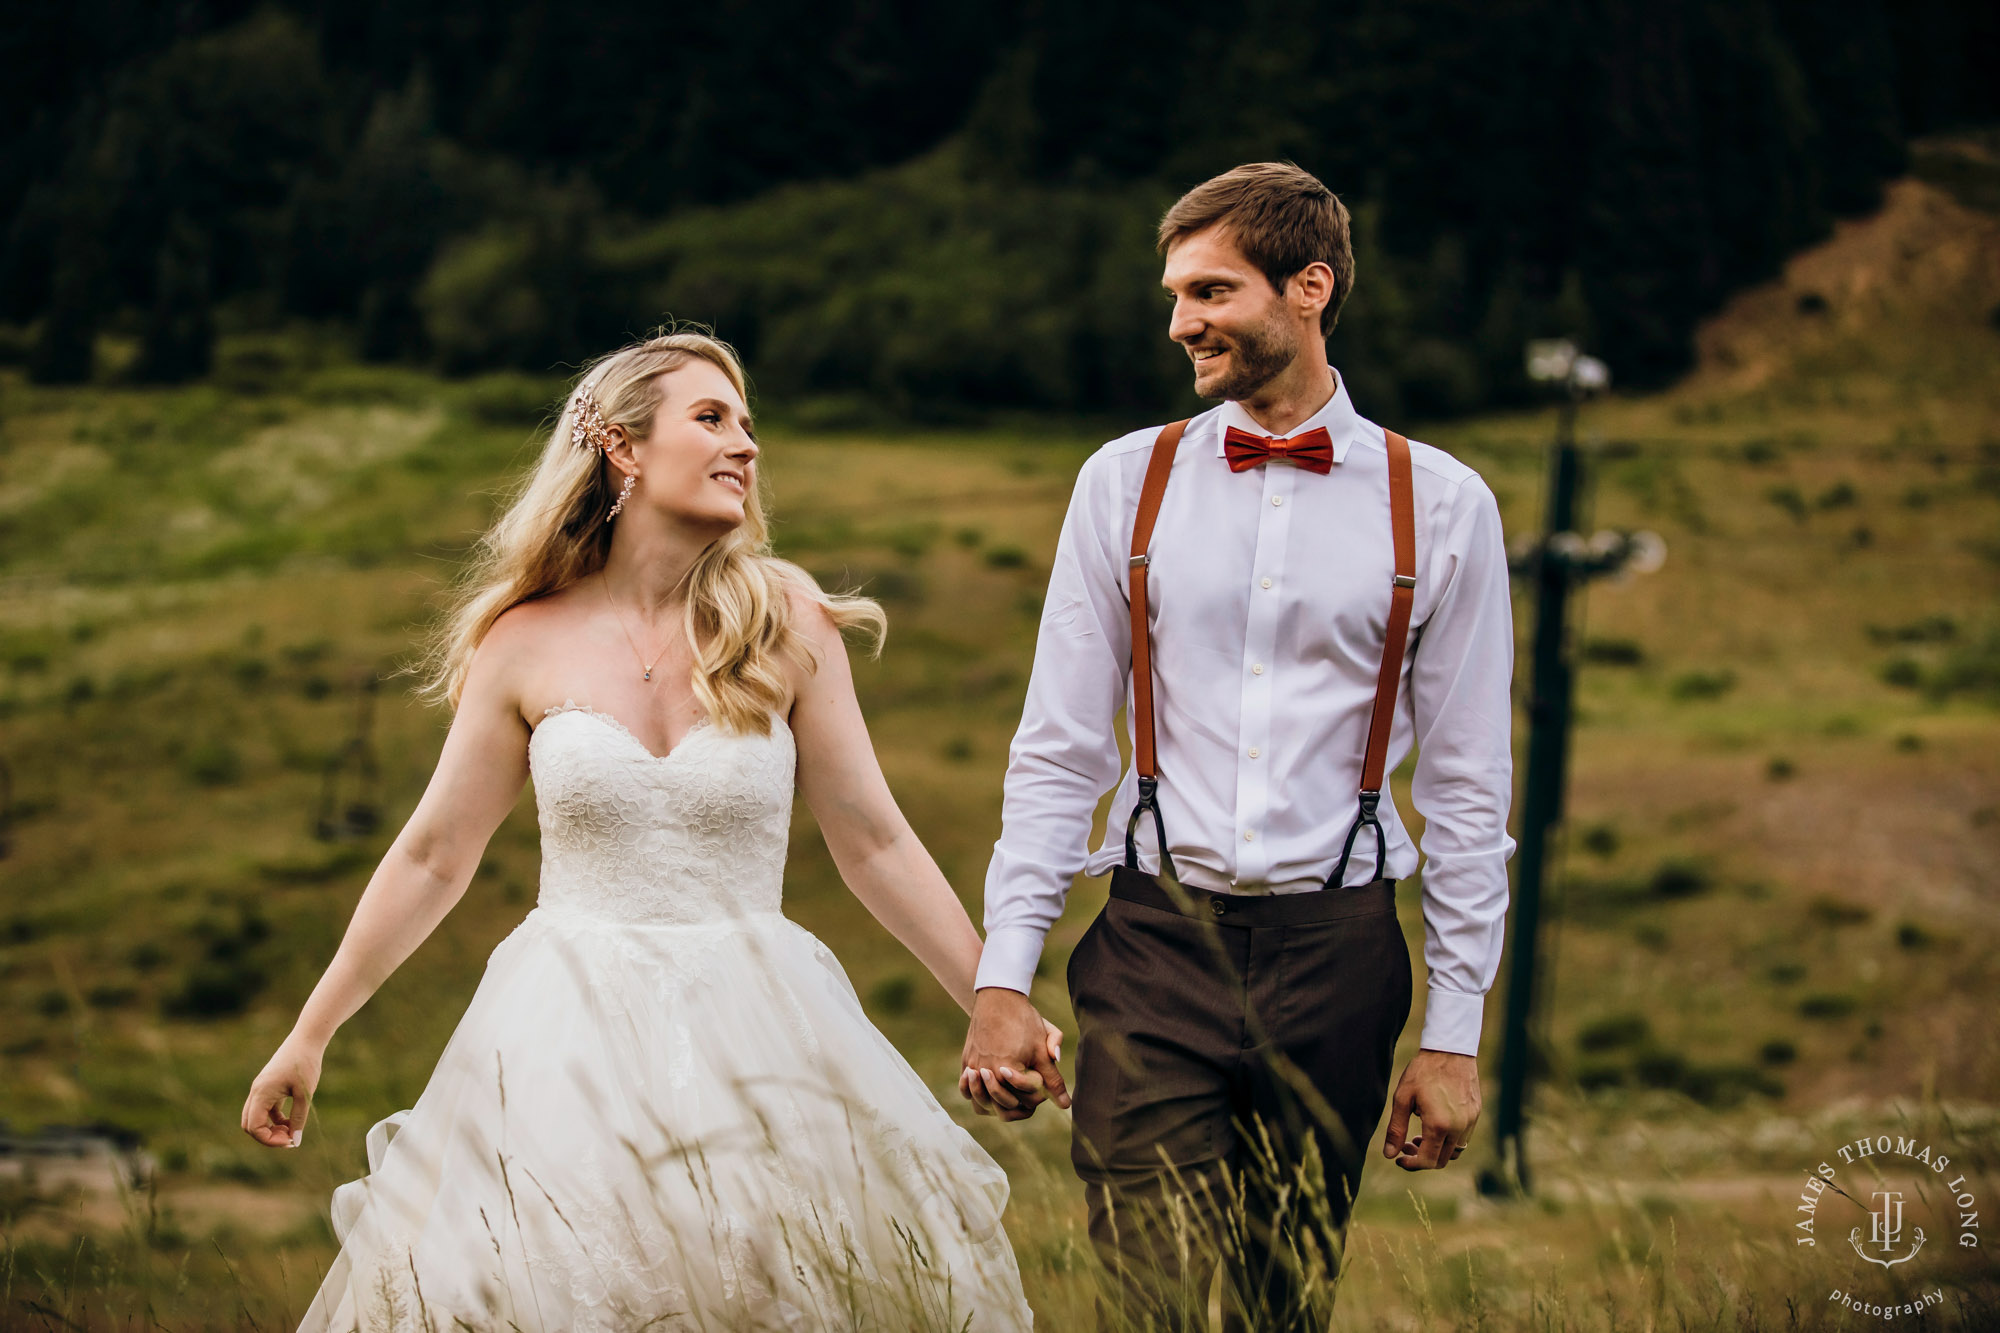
[302,703,1032,1333]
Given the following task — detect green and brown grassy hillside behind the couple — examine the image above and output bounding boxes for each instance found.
[0,184,2000,1329]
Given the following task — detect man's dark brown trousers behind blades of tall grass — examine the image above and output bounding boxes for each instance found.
[1068,869,1412,1333]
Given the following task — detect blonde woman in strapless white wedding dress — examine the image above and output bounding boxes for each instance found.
[242,332,1068,1333]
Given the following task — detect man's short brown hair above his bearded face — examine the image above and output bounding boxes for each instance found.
[1160,162,1354,334]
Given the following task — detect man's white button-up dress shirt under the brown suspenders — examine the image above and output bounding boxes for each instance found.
[978,368,1514,1055]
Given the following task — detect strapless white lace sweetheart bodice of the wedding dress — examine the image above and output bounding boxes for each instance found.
[528,701,796,925]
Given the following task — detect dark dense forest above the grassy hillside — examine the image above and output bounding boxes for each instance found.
[0,0,2000,416]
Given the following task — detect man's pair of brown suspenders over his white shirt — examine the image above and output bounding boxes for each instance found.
[1126,420,1416,889]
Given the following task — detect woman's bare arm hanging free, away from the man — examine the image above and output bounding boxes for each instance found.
[242,624,528,1147]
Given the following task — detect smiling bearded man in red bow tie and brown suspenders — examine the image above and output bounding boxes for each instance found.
[960,162,1514,1329]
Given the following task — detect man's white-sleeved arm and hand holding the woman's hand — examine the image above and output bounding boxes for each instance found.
[960,452,1132,1119]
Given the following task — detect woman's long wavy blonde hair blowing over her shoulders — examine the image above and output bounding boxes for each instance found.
[414,328,888,735]
